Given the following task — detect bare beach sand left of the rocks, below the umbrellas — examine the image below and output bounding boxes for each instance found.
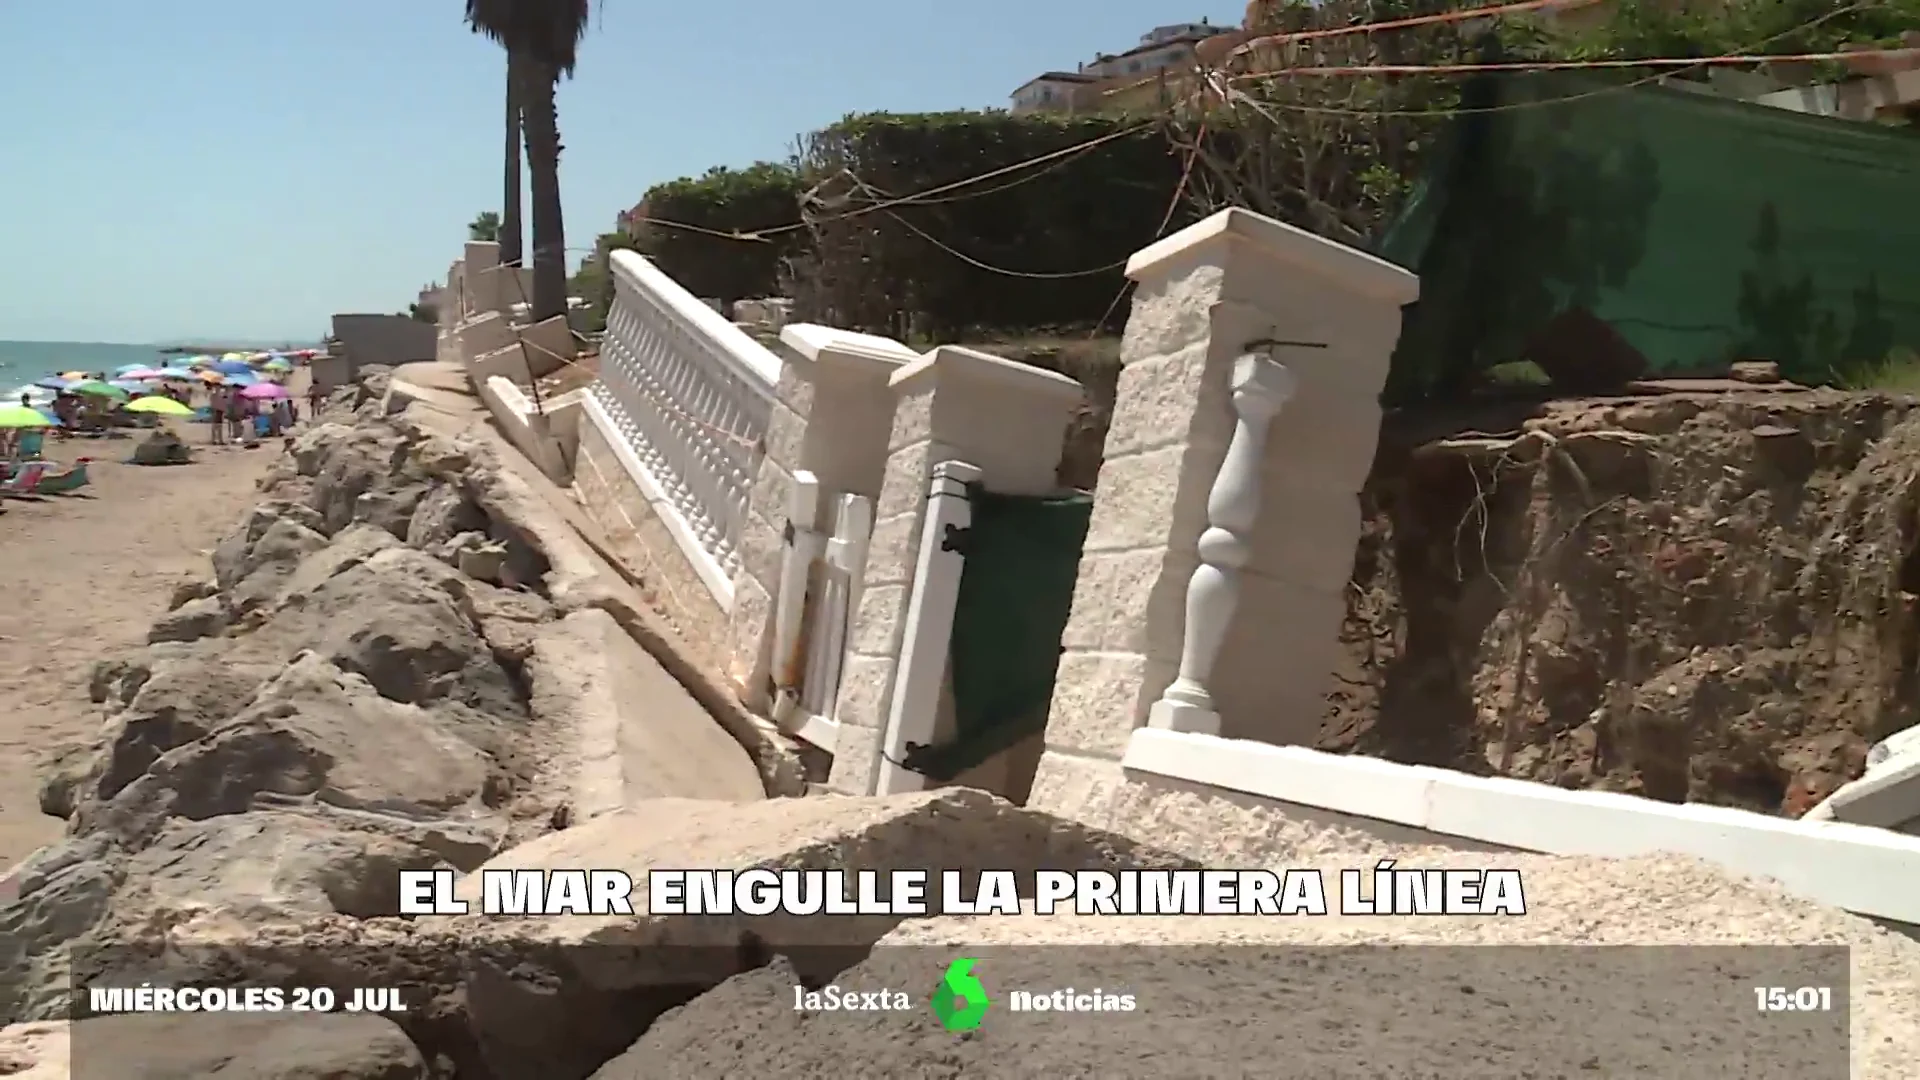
[0,417,299,871]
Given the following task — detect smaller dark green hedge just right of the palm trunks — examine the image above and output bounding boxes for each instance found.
[634,161,806,304]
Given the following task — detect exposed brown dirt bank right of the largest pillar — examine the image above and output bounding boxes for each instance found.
[1321,384,1920,815]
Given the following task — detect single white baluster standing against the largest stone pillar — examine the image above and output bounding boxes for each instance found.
[1146,354,1294,734]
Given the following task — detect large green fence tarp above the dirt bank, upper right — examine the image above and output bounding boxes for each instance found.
[1377,75,1920,402]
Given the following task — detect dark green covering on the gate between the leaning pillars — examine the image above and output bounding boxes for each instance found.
[902,484,1092,780]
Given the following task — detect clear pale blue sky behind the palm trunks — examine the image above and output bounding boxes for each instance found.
[0,0,1244,342]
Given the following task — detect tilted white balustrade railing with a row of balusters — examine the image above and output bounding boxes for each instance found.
[593,252,781,605]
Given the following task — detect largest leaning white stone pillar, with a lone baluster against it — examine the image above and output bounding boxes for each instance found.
[1029,209,1419,821]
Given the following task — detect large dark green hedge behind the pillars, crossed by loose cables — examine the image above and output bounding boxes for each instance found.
[795,111,1185,340]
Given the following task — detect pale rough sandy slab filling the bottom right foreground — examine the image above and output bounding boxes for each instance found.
[593,855,1920,1080]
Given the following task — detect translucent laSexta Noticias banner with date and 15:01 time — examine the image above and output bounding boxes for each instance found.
[71,945,1849,1080]
